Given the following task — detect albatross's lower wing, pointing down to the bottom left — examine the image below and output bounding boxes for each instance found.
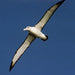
[9,33,35,71]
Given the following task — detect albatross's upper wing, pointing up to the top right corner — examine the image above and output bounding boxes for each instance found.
[35,0,64,31]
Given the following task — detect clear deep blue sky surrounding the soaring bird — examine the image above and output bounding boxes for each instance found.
[0,0,75,75]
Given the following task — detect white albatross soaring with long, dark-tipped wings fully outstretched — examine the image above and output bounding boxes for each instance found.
[9,0,65,71]
